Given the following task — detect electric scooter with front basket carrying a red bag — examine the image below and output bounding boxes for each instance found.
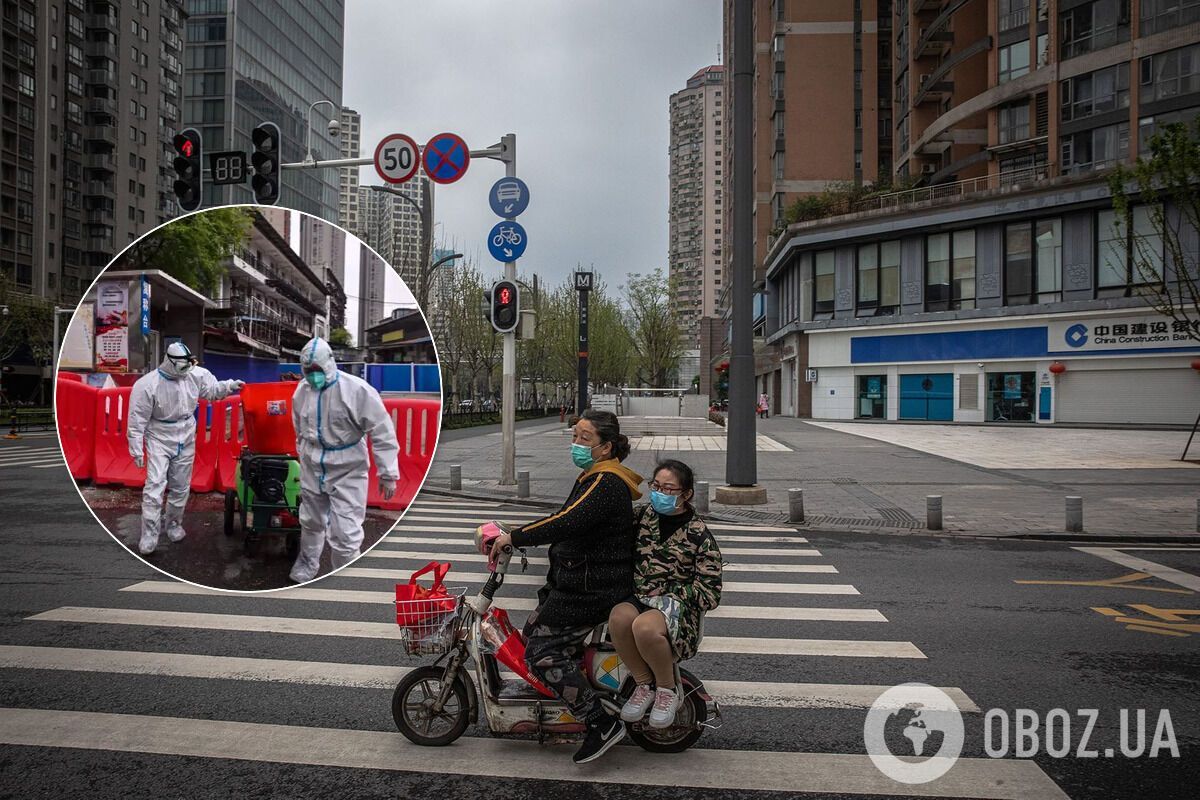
[391,522,721,753]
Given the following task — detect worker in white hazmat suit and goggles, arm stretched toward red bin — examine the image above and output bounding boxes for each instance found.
[126,342,244,555]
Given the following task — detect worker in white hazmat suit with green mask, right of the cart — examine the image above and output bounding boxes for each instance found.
[290,338,400,583]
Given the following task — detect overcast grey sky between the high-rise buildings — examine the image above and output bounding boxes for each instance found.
[343,0,721,297]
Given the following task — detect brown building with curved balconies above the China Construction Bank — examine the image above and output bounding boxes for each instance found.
[756,0,1200,423]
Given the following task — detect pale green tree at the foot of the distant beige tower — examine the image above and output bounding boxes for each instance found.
[625,270,683,389]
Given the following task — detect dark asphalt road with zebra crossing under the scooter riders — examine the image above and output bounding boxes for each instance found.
[0,434,1200,800]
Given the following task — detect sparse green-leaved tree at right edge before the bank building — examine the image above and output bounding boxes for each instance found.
[1109,119,1200,342]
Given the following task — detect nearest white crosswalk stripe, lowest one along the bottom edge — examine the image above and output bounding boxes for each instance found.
[0,709,1067,800]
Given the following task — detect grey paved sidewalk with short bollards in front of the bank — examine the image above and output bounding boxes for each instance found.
[426,417,1200,540]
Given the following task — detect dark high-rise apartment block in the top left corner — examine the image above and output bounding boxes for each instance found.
[0,0,182,305]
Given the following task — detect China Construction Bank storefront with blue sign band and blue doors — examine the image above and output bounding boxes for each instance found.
[788,308,1200,425]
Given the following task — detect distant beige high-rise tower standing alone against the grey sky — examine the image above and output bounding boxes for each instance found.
[667,65,727,348]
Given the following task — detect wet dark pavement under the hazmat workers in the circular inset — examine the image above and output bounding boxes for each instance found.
[79,486,400,591]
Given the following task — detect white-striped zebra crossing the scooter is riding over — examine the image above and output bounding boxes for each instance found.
[0,498,1066,798]
